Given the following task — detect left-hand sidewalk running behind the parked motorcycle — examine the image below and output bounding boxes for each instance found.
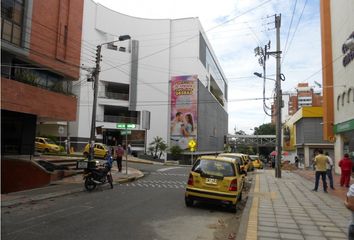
[1,166,144,207]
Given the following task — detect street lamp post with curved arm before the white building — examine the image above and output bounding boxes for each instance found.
[89,35,131,160]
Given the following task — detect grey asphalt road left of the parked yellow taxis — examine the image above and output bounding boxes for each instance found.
[1,164,248,240]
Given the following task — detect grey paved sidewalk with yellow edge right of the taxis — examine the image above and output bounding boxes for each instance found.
[237,170,351,240]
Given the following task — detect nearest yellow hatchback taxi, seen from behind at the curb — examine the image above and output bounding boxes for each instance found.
[185,156,244,211]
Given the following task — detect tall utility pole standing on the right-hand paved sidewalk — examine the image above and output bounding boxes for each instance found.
[275,14,283,178]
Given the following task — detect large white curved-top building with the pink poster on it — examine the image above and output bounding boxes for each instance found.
[70,0,228,158]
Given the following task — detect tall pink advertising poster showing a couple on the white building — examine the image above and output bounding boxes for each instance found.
[170,75,198,150]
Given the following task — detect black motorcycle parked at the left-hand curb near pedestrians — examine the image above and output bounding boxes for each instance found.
[84,160,113,192]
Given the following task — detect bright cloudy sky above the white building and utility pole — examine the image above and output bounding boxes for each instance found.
[95,0,322,134]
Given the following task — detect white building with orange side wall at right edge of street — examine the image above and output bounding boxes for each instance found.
[321,0,354,170]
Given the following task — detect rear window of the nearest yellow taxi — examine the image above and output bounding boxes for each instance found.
[192,159,235,177]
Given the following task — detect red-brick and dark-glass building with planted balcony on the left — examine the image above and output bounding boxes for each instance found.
[1,0,83,155]
